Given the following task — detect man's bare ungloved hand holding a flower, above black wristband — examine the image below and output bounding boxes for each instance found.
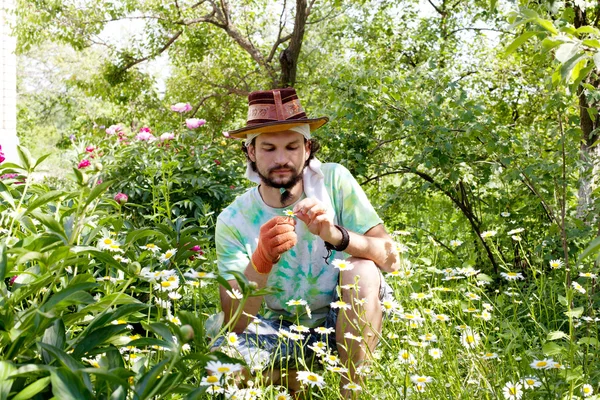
[293,198,341,243]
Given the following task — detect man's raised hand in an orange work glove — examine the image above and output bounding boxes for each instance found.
[252,216,298,274]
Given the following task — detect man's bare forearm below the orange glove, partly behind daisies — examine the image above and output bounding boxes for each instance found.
[220,263,269,333]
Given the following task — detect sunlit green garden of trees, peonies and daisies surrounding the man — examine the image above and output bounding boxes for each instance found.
[0,0,600,400]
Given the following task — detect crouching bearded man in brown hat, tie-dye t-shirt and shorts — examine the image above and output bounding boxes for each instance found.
[216,88,399,397]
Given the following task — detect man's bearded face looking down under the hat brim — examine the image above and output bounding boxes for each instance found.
[248,131,310,189]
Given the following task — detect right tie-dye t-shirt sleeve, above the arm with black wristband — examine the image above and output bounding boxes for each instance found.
[332,164,383,235]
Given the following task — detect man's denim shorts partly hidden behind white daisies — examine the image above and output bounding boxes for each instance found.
[213,272,393,371]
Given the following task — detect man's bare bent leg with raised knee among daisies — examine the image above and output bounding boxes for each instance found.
[336,257,383,398]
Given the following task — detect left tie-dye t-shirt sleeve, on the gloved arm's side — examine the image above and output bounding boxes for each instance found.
[215,218,250,281]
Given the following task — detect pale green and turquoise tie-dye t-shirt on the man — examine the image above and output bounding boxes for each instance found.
[215,163,382,327]
